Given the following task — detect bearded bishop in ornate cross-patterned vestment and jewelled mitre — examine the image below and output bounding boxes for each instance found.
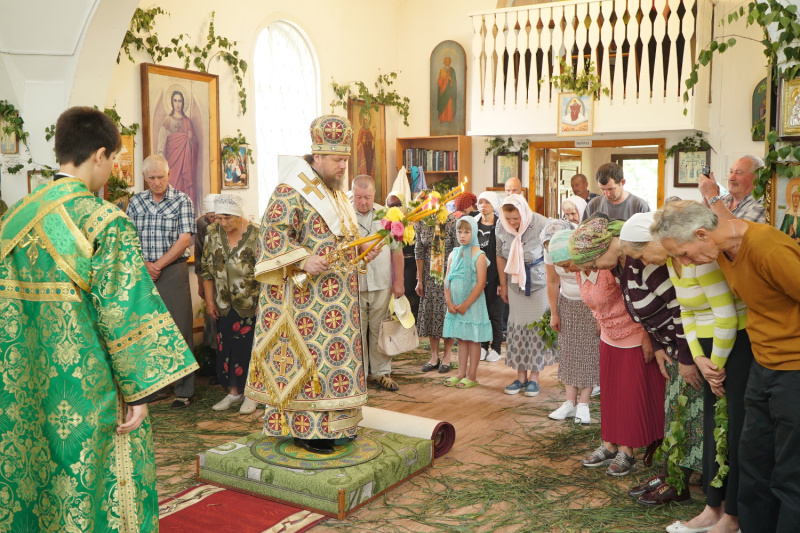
[245,115,379,453]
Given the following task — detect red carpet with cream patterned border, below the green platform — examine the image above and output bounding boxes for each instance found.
[159,485,326,533]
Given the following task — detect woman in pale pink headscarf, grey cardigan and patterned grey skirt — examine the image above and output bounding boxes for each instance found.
[496,194,555,396]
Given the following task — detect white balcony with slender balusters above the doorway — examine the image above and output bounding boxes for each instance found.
[470,0,712,135]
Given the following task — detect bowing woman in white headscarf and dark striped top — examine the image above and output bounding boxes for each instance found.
[611,212,713,507]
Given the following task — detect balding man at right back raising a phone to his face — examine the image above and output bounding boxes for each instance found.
[698,155,767,224]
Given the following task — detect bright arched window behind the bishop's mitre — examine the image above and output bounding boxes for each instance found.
[253,20,320,214]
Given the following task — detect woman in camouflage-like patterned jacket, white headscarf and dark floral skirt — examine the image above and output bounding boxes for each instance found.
[202,194,260,414]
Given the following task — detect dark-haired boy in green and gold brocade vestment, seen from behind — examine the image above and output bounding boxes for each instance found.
[0,107,197,533]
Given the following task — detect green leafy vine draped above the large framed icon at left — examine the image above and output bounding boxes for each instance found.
[117,7,247,114]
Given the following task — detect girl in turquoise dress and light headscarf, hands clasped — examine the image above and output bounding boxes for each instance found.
[442,216,492,389]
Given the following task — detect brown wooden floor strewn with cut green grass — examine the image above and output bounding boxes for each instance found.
[154,342,703,533]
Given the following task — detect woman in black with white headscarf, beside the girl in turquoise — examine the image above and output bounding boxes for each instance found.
[475,191,505,363]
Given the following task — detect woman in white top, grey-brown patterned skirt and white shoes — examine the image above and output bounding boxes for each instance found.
[541,219,600,424]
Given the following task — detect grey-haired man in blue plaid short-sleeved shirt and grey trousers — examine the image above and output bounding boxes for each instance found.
[128,155,196,409]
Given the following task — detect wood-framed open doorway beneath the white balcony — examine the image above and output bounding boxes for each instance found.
[528,139,666,218]
